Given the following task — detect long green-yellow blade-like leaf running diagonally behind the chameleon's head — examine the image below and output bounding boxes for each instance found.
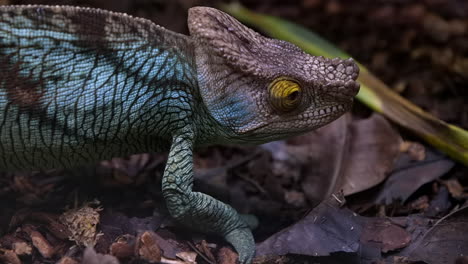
[222,3,468,166]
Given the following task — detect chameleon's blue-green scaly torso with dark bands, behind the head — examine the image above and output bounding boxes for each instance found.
[0,6,196,169]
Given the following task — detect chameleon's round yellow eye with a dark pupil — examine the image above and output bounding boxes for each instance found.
[268,78,302,113]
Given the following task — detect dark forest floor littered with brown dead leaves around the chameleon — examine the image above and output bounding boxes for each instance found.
[0,0,468,264]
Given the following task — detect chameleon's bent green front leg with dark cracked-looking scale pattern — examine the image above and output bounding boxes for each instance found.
[162,133,255,264]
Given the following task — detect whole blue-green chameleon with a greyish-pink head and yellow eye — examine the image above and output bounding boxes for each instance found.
[0,5,359,264]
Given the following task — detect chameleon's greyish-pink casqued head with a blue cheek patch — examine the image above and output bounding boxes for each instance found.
[188,7,359,143]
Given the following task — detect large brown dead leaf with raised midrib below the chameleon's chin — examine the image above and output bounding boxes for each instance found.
[265,114,401,206]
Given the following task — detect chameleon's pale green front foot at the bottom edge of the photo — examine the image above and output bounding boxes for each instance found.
[224,228,255,264]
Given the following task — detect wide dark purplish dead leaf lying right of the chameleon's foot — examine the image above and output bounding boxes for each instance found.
[256,201,436,263]
